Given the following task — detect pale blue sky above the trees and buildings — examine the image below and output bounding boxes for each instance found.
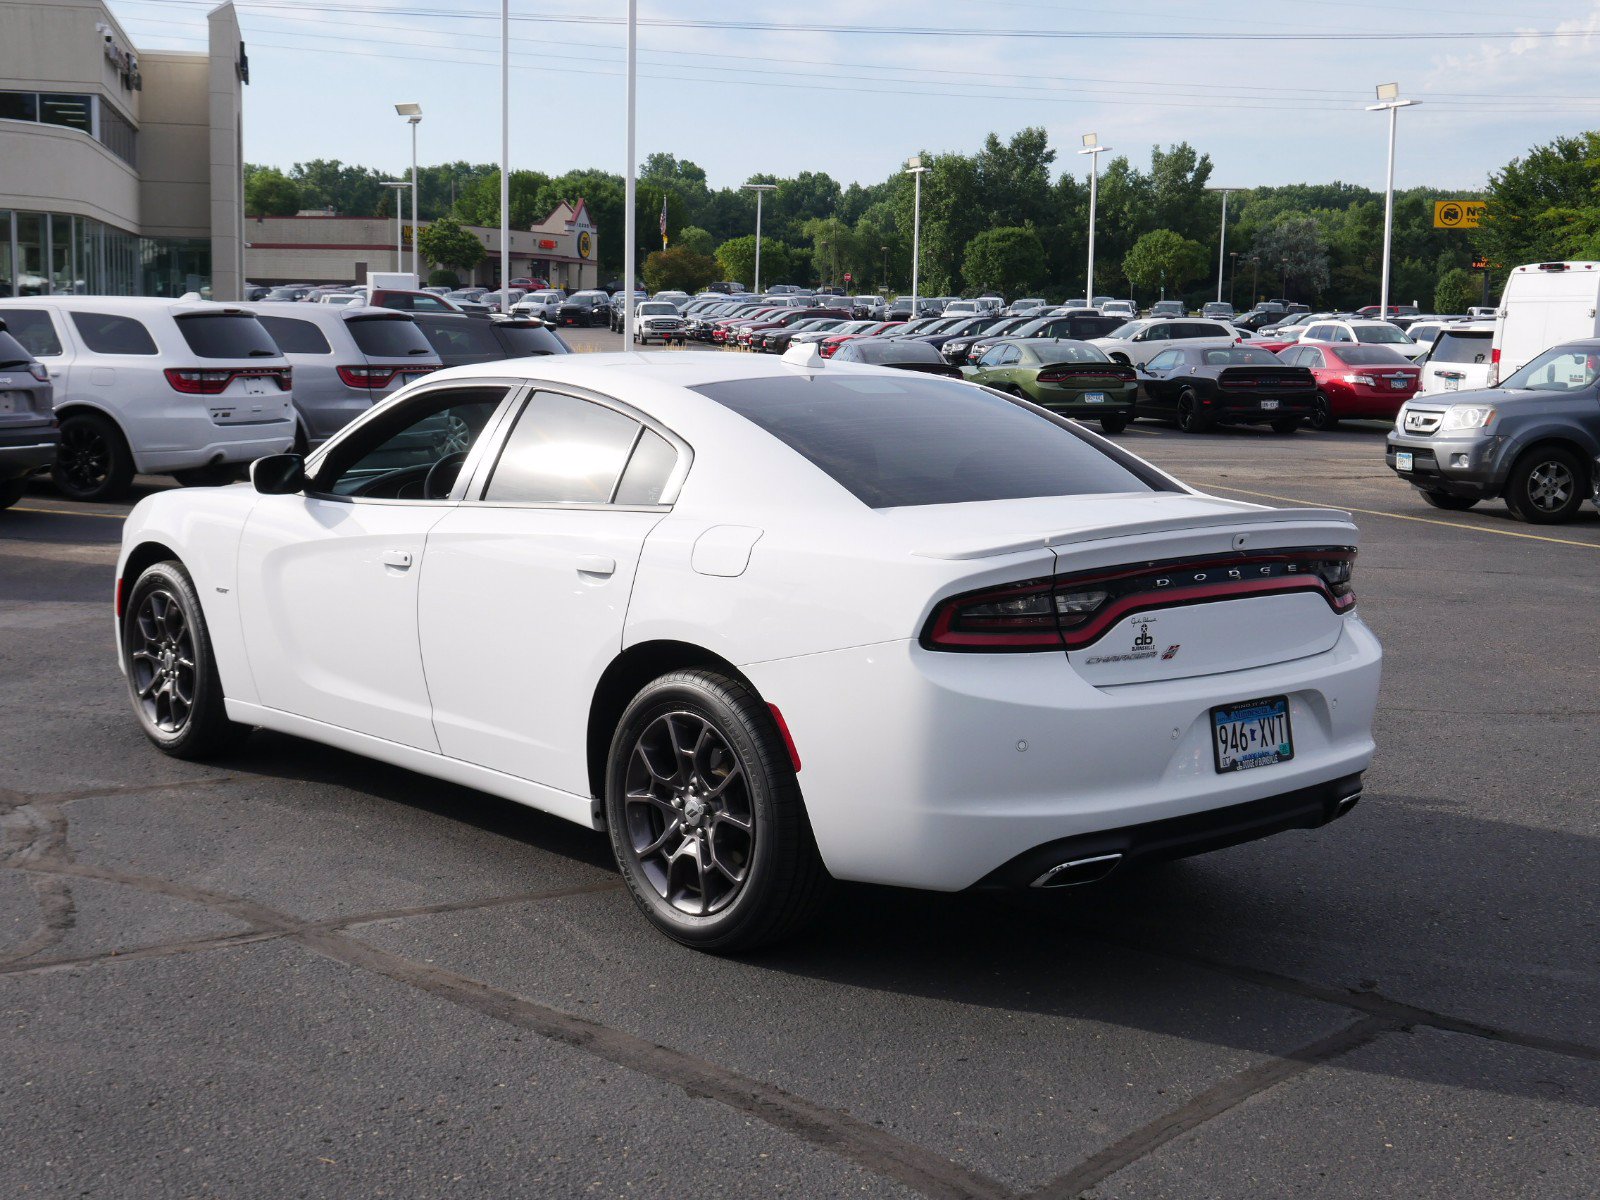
[109,0,1600,189]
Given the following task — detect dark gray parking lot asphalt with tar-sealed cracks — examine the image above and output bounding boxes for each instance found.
[0,333,1600,1200]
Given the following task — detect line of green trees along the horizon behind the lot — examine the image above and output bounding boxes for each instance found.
[246,128,1516,310]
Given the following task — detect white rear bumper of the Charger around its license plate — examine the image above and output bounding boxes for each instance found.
[746,618,1382,891]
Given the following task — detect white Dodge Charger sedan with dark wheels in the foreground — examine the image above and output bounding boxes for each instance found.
[117,347,1381,950]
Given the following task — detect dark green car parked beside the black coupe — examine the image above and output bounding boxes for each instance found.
[962,338,1139,434]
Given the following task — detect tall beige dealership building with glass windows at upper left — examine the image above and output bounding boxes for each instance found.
[0,0,250,299]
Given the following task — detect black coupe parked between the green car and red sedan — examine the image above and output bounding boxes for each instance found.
[1133,346,1317,434]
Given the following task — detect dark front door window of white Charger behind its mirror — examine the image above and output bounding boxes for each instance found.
[310,387,506,501]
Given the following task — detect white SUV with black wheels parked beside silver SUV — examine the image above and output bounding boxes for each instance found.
[0,296,294,501]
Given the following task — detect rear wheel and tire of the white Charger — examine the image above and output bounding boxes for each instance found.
[605,670,832,954]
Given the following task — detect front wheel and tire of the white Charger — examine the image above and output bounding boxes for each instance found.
[122,562,250,758]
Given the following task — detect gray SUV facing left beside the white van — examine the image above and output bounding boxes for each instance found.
[1384,339,1600,525]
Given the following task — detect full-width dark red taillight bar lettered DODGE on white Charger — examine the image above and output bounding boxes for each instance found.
[922,547,1355,653]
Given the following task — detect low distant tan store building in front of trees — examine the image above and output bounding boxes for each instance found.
[245,198,600,291]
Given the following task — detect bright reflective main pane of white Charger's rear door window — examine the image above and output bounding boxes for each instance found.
[483,392,640,504]
